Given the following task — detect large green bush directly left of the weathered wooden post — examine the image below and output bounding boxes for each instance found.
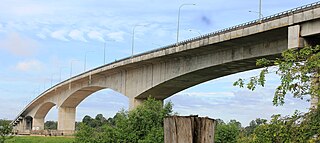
[76,98,172,143]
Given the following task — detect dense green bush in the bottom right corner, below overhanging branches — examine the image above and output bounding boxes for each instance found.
[253,108,320,143]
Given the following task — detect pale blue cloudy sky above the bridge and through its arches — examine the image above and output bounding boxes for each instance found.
[0,0,316,125]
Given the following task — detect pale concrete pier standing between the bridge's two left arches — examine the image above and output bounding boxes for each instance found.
[58,107,76,132]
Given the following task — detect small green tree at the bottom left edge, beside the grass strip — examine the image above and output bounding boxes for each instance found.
[0,119,14,143]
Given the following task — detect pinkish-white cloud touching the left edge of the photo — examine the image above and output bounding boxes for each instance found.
[0,33,38,56]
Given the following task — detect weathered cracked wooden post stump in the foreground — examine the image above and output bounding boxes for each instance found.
[164,116,216,143]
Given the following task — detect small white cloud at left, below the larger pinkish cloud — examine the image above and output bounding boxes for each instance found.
[16,60,43,71]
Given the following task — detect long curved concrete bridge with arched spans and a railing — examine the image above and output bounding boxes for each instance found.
[12,2,320,134]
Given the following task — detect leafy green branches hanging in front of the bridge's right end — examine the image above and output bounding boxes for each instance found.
[233,45,320,105]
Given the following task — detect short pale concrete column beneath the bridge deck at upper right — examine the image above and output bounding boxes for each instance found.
[288,25,304,49]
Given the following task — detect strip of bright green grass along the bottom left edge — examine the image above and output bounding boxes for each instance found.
[5,136,74,143]
